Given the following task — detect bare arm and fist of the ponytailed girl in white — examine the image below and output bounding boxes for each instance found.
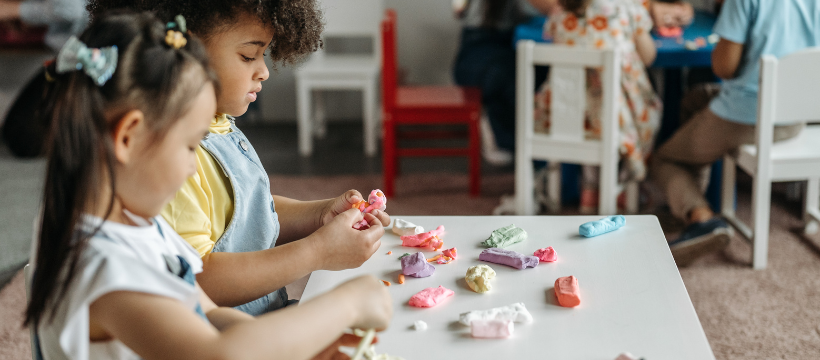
[89,276,392,360]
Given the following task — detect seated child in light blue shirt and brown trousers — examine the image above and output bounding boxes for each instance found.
[652,0,820,266]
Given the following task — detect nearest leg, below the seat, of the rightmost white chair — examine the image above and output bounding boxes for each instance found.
[752,172,772,270]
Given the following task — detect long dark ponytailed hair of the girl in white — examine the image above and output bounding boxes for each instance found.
[25,12,217,327]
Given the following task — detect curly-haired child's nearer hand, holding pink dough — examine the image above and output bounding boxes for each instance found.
[308,208,384,270]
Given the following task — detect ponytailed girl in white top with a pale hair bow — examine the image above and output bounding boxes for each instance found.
[26,13,392,359]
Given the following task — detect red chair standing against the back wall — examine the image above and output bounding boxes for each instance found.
[382,9,481,196]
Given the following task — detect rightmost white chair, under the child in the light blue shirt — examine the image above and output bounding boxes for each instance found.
[721,48,820,269]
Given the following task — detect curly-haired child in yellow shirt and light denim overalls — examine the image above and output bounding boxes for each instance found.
[88,0,390,315]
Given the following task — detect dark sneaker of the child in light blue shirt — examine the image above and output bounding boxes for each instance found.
[669,218,729,267]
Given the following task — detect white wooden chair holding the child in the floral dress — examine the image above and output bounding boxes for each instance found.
[515,40,638,215]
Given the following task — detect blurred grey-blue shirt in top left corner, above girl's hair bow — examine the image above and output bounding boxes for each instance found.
[20,0,88,51]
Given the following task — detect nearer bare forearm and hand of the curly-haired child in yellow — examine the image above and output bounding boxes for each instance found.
[197,209,384,306]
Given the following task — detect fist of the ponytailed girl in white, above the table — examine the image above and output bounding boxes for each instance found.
[336,275,393,331]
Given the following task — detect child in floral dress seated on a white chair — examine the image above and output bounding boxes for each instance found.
[535,0,662,213]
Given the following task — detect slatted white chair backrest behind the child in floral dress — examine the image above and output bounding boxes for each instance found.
[516,40,621,164]
